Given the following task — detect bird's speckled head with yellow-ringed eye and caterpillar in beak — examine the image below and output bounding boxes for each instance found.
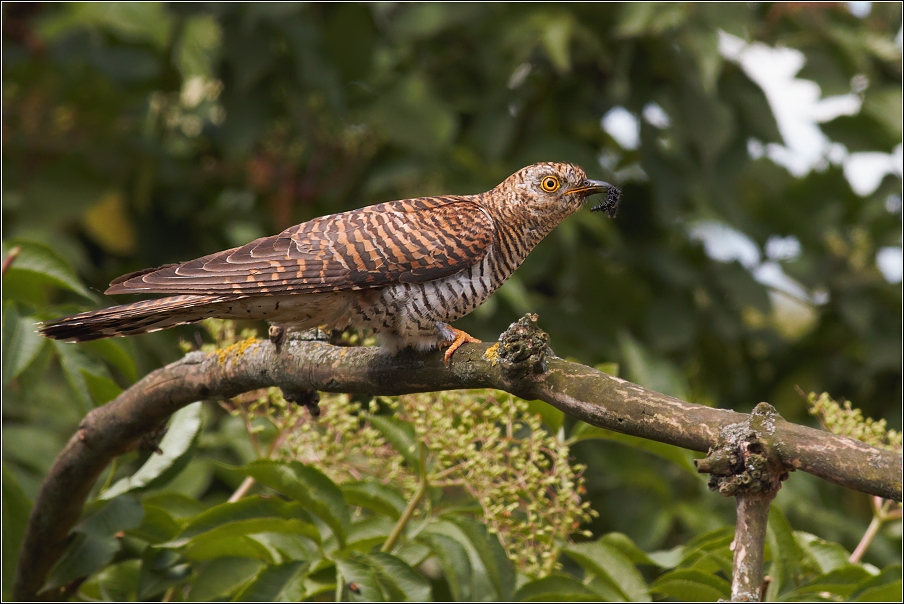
[493,162,621,220]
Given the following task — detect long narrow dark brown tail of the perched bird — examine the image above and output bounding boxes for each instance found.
[38,295,236,342]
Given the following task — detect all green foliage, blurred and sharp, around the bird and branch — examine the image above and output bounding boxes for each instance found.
[2,3,902,600]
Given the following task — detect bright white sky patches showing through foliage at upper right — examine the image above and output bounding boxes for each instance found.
[601,2,904,290]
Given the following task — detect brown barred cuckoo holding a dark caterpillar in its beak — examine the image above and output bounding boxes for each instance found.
[39,162,621,365]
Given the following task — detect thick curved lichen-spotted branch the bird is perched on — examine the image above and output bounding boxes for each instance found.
[14,332,902,600]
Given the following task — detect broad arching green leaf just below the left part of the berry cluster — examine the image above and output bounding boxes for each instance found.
[245,460,350,547]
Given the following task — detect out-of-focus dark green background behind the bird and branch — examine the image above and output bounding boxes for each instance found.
[2,3,902,595]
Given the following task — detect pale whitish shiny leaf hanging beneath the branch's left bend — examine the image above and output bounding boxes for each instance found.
[100,402,203,499]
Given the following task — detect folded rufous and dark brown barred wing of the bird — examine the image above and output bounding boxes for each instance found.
[106,197,494,295]
